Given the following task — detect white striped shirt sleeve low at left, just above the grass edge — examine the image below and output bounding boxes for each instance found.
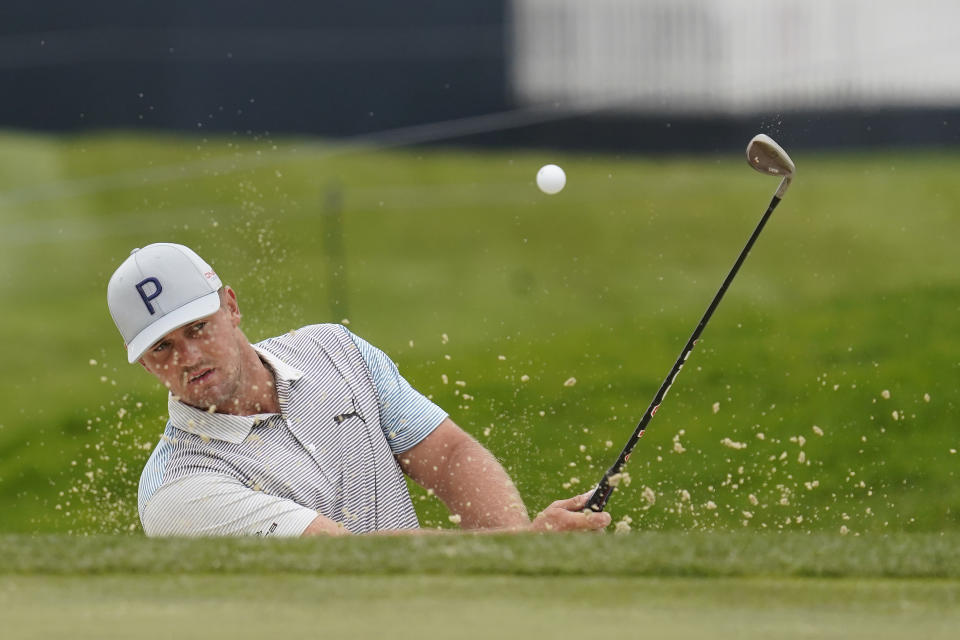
[141,473,317,537]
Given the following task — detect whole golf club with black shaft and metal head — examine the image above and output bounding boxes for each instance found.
[584,133,796,511]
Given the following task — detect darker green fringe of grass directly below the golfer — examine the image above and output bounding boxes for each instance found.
[0,532,960,580]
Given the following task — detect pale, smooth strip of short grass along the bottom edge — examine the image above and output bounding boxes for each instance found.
[0,574,960,640]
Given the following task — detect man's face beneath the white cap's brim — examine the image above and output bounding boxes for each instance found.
[140,288,246,409]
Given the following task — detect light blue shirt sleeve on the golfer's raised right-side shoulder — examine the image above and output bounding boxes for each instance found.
[344,329,447,454]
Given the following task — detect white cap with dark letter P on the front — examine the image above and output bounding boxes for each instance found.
[107,242,223,362]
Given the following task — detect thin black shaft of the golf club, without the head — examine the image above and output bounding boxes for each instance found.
[584,192,780,511]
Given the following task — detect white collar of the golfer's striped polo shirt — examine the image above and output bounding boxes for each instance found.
[167,345,303,444]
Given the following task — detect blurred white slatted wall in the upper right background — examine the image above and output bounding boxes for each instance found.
[510,0,960,114]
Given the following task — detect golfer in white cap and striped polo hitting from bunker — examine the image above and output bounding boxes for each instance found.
[107,243,610,536]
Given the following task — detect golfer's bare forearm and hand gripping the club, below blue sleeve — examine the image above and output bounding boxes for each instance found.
[397,418,610,531]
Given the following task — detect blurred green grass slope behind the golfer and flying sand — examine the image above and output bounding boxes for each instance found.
[0,132,960,535]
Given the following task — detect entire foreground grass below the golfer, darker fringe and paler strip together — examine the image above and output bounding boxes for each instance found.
[0,532,960,639]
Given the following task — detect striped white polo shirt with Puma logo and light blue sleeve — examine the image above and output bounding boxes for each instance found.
[138,325,447,536]
